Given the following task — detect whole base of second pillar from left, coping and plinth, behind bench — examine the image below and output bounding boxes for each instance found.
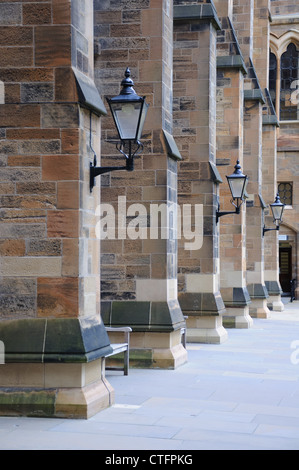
[102,299,187,369]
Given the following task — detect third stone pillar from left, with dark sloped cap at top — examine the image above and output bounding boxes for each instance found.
[174,2,227,343]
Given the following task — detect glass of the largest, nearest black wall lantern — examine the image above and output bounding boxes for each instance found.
[111,101,142,140]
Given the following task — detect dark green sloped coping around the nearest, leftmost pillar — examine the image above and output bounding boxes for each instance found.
[0,316,112,363]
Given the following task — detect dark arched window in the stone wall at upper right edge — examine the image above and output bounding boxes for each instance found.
[269,42,299,121]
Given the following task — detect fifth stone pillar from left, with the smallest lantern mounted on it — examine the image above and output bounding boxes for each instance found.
[233,0,270,318]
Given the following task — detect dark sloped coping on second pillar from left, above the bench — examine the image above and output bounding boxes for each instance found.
[102,300,185,332]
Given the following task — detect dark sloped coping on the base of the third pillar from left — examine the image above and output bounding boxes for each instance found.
[178,292,225,316]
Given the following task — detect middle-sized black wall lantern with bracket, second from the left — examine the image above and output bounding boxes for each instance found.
[216,160,248,223]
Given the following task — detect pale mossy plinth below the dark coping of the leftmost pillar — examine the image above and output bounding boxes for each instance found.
[0,359,114,419]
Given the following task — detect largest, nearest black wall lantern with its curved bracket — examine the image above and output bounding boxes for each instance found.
[90,68,149,191]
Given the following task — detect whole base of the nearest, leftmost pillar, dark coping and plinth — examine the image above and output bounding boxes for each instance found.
[0,315,114,419]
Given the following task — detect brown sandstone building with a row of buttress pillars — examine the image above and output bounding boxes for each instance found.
[0,0,299,418]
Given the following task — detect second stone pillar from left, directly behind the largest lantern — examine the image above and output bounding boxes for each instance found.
[95,0,187,368]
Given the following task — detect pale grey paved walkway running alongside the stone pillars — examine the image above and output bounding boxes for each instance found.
[0,299,299,454]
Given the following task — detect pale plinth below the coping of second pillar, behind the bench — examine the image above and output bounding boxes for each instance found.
[106,330,188,369]
